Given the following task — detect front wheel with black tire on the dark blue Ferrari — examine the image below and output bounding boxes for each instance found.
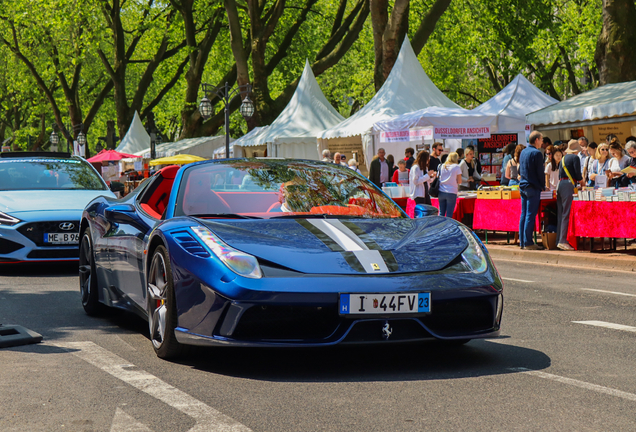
[146,246,185,360]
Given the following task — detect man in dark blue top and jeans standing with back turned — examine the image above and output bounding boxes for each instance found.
[519,131,545,250]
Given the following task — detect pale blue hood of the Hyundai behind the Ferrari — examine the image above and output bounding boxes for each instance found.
[0,190,115,214]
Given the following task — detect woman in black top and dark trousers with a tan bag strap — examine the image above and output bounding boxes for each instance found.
[557,140,583,250]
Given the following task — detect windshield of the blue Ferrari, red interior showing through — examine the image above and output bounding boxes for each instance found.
[175,159,406,219]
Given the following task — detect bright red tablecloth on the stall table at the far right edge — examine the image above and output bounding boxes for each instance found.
[568,201,636,248]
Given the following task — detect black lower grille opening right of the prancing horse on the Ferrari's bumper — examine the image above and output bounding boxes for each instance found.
[420,296,496,337]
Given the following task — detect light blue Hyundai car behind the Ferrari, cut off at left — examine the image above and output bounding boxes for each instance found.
[0,152,115,264]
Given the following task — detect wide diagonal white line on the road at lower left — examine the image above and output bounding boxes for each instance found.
[55,342,251,432]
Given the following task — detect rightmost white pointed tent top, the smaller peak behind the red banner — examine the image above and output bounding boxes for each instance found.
[472,74,559,133]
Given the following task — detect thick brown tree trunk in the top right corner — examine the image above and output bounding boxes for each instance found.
[594,0,636,85]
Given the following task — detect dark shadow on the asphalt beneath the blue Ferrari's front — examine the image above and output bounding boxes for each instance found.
[182,340,550,382]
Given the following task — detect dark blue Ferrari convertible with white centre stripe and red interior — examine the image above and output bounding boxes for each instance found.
[80,158,503,358]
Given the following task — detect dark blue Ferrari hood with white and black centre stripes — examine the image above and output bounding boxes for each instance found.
[200,216,468,274]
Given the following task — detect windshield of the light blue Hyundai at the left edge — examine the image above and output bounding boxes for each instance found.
[0,158,106,191]
